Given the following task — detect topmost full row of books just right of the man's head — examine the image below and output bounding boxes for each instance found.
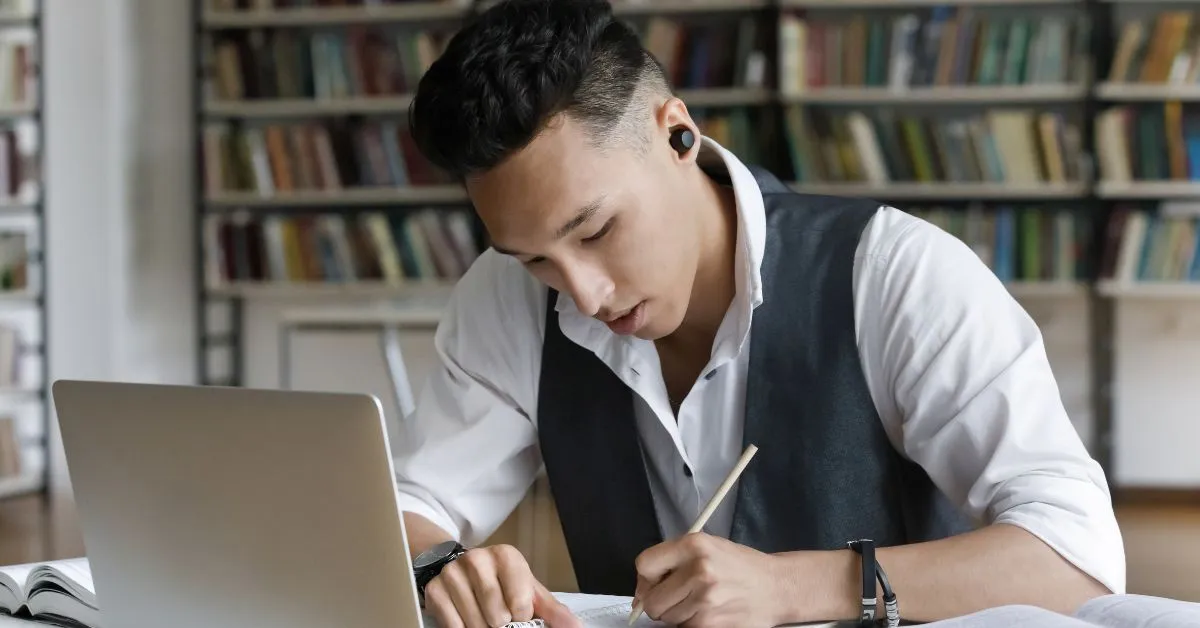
[779,6,1091,95]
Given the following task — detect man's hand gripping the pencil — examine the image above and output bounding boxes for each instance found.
[634,533,796,628]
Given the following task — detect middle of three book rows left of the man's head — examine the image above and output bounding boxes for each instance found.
[203,118,452,196]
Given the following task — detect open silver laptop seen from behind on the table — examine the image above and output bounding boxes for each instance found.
[53,381,422,628]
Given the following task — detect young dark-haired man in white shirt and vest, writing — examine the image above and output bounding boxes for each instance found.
[396,0,1124,628]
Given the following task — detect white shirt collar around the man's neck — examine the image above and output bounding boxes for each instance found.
[554,136,767,348]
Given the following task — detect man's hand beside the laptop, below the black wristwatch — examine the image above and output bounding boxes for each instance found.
[425,545,582,628]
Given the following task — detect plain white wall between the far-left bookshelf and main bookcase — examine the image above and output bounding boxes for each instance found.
[43,0,193,488]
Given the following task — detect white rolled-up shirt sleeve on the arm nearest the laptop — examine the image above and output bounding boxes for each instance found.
[392,251,545,545]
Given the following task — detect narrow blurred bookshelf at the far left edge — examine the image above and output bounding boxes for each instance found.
[0,0,43,498]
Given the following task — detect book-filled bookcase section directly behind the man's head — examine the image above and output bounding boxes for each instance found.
[193,0,778,385]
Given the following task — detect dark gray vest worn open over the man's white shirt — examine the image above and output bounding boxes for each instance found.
[538,168,972,596]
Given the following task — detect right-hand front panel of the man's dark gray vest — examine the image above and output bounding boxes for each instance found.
[731,164,904,552]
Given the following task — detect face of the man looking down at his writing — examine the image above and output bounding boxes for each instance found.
[467,110,698,340]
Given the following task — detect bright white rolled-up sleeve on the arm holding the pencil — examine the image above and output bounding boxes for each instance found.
[856,208,1126,593]
